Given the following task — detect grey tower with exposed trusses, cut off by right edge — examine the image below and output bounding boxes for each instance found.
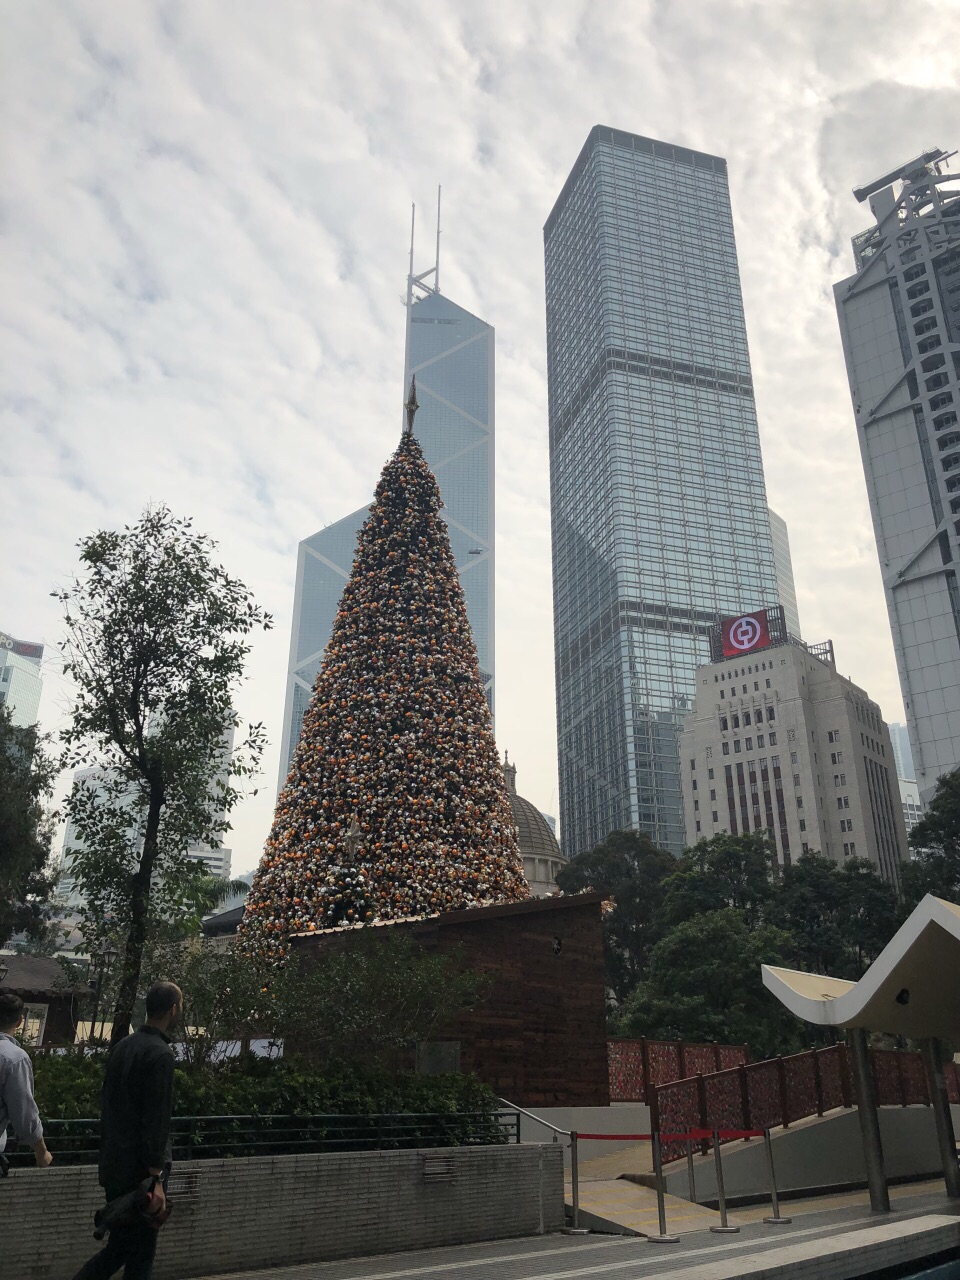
[833,150,960,803]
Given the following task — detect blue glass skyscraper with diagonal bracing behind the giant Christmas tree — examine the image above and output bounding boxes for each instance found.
[278,286,494,790]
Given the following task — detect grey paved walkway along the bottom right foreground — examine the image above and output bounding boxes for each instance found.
[195,1184,960,1280]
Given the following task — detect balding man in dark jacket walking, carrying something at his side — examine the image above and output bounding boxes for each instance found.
[74,982,183,1280]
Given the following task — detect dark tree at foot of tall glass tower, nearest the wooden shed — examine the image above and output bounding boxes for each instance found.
[557,831,677,1001]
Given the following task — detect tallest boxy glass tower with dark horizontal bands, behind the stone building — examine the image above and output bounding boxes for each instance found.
[544,125,778,858]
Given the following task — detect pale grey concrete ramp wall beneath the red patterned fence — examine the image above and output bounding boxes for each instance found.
[666,1107,960,1202]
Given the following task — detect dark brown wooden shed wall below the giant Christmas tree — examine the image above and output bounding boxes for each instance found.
[293,893,609,1107]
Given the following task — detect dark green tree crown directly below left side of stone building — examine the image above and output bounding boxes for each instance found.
[662,832,774,929]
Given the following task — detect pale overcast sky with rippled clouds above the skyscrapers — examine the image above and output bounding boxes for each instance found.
[0,0,960,872]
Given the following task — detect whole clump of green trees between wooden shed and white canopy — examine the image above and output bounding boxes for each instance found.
[570,832,904,1052]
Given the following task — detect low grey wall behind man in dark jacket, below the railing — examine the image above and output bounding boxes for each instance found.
[0,1144,563,1280]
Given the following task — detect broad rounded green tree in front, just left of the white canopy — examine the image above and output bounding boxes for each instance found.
[618,908,801,1056]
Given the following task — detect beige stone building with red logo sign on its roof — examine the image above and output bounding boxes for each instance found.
[680,614,908,886]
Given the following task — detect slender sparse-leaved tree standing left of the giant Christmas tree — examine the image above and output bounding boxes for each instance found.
[54,506,270,1042]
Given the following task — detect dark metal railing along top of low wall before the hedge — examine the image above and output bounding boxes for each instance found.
[6,1110,520,1167]
